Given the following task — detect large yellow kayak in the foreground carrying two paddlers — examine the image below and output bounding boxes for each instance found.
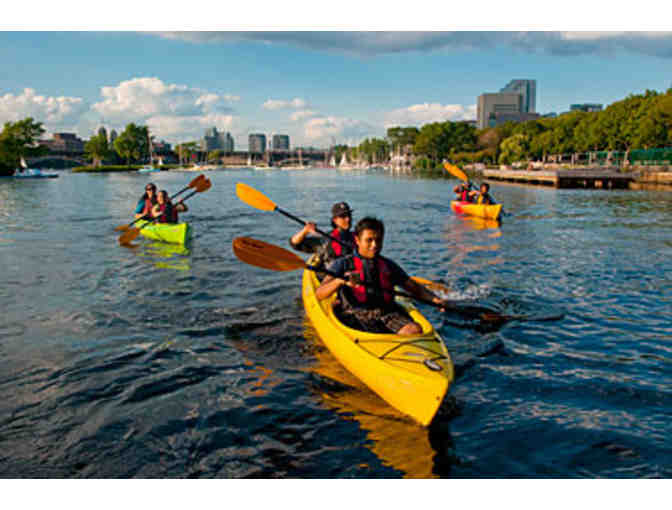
[302,255,454,426]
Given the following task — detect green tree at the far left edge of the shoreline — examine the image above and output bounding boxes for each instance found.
[0,117,48,175]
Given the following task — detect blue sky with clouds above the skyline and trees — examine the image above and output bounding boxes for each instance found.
[0,23,672,149]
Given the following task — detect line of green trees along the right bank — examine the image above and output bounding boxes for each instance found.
[346,88,672,168]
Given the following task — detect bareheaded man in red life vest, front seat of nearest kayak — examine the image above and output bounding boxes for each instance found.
[315,217,446,335]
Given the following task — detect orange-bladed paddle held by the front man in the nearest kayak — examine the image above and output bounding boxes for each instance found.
[233,237,522,322]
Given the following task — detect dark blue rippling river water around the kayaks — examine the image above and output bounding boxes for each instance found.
[0,169,672,478]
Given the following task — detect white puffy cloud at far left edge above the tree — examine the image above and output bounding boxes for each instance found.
[0,88,89,127]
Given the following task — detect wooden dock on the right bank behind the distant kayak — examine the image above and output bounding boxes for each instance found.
[482,168,639,189]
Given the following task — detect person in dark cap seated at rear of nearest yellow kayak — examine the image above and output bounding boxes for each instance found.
[289,202,355,266]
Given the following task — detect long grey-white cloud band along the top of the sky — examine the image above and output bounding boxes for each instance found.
[152,31,672,58]
